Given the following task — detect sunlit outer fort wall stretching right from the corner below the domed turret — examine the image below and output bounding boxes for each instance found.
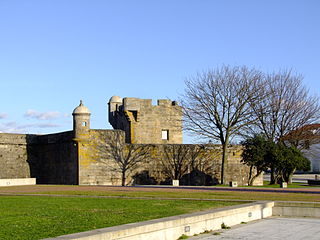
[78,137,263,185]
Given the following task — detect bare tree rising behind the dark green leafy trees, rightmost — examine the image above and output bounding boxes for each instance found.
[251,70,320,184]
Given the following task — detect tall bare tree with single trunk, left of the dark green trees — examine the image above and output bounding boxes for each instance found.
[181,66,262,184]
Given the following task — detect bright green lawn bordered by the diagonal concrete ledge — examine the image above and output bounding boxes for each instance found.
[0,196,239,240]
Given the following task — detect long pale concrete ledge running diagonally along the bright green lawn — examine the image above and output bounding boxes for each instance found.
[48,202,274,240]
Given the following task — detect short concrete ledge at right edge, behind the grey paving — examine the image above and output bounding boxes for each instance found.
[272,202,320,218]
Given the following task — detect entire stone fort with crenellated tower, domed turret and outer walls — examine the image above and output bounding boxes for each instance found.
[0,96,262,185]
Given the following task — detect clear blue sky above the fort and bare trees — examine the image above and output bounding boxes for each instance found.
[0,0,320,142]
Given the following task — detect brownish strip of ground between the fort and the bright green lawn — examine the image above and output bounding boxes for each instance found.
[0,185,320,202]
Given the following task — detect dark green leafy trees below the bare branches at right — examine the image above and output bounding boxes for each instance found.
[242,135,310,185]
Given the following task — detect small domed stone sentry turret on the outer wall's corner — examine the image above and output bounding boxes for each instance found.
[72,100,91,139]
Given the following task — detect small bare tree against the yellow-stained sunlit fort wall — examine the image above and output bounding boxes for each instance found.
[107,132,153,186]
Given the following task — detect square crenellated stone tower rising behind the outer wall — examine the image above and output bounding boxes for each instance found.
[109,96,182,144]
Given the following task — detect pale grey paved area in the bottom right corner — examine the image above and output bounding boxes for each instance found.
[188,218,320,240]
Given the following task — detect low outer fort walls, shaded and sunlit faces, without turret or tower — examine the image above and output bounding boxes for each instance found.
[0,130,262,185]
